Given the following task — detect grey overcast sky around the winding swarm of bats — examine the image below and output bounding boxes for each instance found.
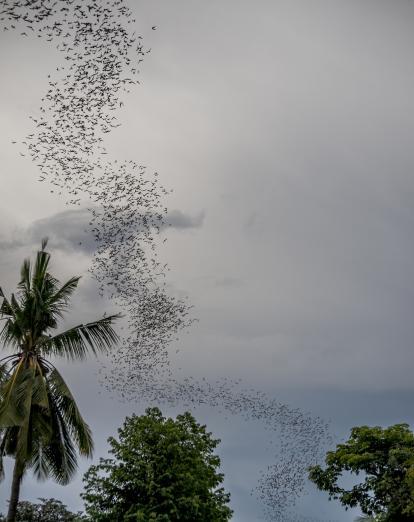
[0,0,414,522]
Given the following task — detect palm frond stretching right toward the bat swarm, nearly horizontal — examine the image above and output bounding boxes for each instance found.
[38,314,121,360]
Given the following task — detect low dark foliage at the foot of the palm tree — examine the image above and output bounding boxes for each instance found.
[0,498,85,522]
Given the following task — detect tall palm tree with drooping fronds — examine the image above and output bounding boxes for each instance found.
[0,239,119,522]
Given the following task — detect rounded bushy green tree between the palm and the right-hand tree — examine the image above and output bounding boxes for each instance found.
[82,408,232,522]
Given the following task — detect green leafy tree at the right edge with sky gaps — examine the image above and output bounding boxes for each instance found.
[309,424,414,522]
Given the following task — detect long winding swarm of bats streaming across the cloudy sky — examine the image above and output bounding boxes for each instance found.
[0,0,329,521]
